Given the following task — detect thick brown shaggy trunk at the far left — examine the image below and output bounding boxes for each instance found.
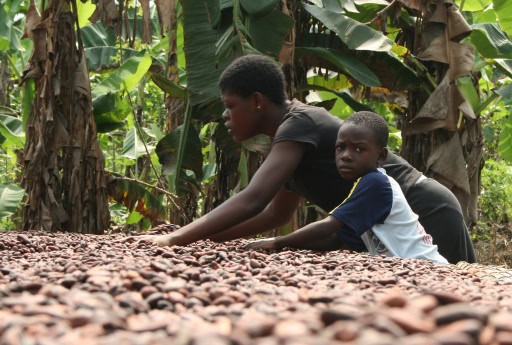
[22,0,110,234]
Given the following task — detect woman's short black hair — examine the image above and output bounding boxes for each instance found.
[219,54,287,104]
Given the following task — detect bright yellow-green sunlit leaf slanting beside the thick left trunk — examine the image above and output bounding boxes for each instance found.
[92,50,151,98]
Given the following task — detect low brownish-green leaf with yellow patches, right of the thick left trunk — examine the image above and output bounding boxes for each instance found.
[107,178,165,220]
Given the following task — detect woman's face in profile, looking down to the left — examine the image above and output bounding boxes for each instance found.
[222,93,262,142]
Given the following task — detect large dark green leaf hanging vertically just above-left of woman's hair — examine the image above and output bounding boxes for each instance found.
[182,1,229,105]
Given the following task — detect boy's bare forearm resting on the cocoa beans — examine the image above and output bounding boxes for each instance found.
[246,216,343,249]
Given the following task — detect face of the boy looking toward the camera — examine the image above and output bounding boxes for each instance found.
[335,123,387,181]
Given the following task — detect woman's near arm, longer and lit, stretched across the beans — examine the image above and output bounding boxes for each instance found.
[151,141,305,246]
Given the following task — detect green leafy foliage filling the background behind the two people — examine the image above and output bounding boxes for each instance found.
[0,0,512,264]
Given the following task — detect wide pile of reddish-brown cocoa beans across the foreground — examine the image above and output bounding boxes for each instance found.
[0,232,512,345]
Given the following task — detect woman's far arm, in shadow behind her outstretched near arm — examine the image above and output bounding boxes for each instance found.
[209,187,301,242]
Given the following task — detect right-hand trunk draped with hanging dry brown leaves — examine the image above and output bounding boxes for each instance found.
[402,0,483,224]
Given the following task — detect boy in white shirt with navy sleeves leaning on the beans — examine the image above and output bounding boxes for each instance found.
[247,112,448,264]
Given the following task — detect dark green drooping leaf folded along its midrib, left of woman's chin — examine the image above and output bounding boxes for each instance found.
[156,125,203,179]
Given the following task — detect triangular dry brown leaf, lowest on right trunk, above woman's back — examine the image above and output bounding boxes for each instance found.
[427,133,470,195]
